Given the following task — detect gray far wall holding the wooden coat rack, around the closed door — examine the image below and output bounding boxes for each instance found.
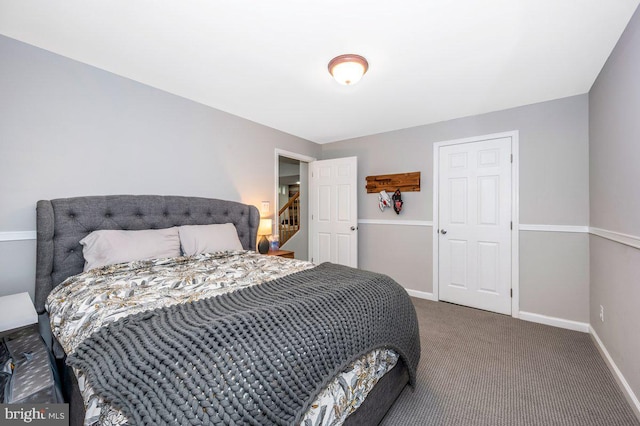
[322,94,589,322]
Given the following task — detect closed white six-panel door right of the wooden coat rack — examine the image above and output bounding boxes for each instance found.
[436,137,513,314]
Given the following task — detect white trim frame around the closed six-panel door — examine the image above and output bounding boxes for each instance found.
[432,130,520,318]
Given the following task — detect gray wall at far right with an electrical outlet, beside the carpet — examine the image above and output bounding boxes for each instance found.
[589,4,640,410]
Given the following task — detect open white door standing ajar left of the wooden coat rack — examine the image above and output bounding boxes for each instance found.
[309,157,358,268]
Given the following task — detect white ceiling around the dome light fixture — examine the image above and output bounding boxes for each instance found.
[0,0,640,143]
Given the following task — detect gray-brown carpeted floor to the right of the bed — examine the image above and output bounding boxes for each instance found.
[382,299,640,426]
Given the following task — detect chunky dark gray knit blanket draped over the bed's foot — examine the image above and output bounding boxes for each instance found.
[67,263,420,425]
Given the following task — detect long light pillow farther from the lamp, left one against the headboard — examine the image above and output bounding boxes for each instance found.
[80,227,180,271]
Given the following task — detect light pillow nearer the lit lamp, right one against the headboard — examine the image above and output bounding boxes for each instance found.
[178,223,242,256]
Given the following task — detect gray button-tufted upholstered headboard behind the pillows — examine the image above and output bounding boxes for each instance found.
[35,195,260,314]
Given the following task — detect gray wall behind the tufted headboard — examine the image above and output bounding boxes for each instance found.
[0,36,320,295]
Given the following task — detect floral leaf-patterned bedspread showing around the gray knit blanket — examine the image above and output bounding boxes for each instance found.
[47,251,398,426]
